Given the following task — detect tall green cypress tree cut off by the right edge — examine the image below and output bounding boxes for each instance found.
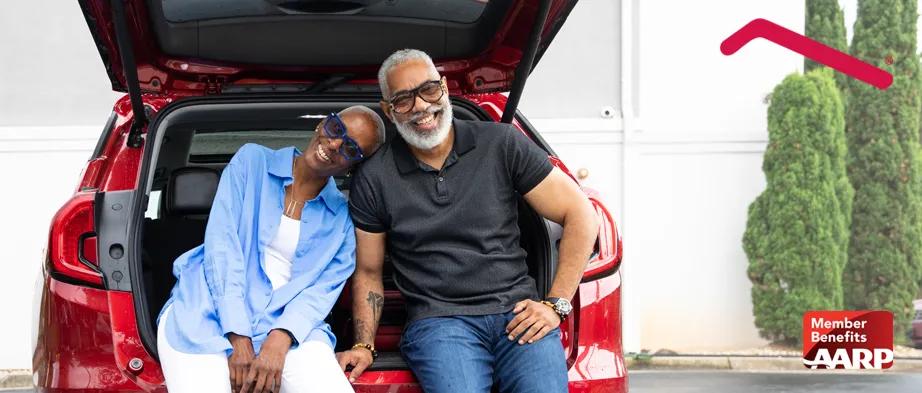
[843,0,922,340]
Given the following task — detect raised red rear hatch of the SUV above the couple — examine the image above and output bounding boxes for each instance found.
[79,0,577,95]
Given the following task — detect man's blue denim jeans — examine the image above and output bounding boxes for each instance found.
[400,312,567,393]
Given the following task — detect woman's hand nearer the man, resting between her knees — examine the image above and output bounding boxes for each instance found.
[242,330,291,393]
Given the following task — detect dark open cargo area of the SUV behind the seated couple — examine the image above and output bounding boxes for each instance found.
[132,96,560,371]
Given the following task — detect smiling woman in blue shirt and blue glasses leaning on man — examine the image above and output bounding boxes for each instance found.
[157,107,384,393]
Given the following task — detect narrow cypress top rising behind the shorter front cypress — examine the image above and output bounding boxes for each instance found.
[804,0,848,89]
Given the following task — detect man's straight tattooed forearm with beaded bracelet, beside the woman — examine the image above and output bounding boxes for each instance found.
[337,228,386,382]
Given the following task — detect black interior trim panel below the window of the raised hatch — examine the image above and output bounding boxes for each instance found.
[147,0,512,67]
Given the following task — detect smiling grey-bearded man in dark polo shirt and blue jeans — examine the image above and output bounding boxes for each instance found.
[338,49,598,393]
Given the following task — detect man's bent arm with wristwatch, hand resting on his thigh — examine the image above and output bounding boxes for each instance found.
[506,168,599,344]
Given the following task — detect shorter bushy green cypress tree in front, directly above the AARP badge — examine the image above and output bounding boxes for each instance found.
[743,69,851,344]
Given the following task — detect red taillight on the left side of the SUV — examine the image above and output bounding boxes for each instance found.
[47,193,102,286]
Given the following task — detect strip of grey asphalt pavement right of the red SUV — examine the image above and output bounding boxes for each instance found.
[628,371,922,393]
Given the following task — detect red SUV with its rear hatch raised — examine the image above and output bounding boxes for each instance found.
[33,0,627,392]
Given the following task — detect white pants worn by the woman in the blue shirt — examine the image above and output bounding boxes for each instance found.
[157,310,353,393]
